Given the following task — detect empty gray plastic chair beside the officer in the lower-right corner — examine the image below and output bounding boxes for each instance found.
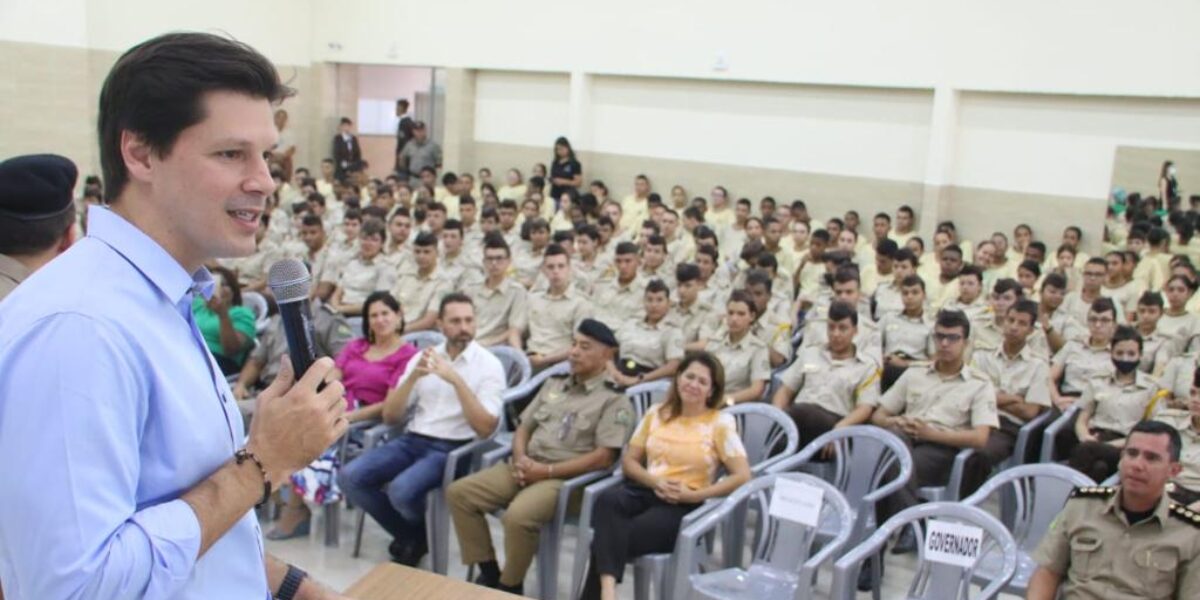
[962,464,1096,596]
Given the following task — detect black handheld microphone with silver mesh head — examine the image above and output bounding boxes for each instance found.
[266,258,324,384]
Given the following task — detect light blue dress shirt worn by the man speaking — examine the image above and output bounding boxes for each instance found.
[0,206,270,600]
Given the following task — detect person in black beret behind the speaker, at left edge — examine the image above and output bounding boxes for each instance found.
[0,154,78,301]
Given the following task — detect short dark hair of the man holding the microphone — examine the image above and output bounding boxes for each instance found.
[97,34,295,203]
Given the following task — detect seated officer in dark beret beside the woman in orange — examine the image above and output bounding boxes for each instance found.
[446,319,635,594]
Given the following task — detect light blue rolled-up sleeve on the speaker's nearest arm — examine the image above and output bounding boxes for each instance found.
[0,314,200,599]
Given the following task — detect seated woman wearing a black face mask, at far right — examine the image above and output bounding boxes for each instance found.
[1069,325,1165,481]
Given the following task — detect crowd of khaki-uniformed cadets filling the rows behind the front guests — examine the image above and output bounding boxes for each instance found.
[216,161,1200,503]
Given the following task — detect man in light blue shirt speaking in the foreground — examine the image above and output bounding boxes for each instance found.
[0,34,347,600]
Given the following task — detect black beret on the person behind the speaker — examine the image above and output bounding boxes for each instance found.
[0,154,79,221]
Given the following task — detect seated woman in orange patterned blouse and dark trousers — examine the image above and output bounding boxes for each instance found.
[582,352,750,600]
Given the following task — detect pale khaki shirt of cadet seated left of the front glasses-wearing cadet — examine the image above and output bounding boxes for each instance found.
[780,346,881,416]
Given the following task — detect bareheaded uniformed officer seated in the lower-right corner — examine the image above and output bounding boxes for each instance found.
[1026,421,1200,600]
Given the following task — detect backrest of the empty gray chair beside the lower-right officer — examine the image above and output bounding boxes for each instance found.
[962,464,1096,552]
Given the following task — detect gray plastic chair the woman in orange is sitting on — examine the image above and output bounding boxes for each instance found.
[571,400,800,600]
